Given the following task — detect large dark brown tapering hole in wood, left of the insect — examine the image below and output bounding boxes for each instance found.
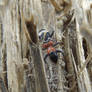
[25,17,38,44]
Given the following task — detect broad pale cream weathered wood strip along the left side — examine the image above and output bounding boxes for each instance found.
[3,1,24,92]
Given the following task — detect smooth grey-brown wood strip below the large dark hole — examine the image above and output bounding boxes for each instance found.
[31,47,49,92]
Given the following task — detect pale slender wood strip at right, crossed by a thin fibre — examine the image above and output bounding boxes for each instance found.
[76,18,92,92]
